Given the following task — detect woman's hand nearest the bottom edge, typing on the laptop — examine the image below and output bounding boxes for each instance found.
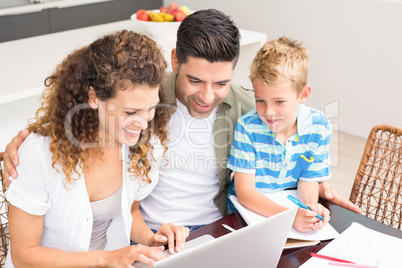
[105,245,165,268]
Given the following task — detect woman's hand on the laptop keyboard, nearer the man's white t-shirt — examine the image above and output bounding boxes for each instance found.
[147,223,190,253]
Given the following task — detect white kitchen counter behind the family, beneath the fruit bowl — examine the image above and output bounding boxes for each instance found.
[0,19,267,152]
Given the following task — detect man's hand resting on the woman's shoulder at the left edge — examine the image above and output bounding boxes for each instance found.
[3,129,29,188]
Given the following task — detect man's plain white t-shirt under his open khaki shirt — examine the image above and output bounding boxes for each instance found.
[141,100,222,229]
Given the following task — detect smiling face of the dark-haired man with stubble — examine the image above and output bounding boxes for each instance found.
[172,53,233,118]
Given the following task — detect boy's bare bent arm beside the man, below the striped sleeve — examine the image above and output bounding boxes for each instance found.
[234,172,288,217]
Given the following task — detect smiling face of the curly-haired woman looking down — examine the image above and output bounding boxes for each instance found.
[98,85,159,147]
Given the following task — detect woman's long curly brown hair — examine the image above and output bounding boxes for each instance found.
[28,30,169,184]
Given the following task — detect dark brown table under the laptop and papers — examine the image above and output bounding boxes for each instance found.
[188,199,402,268]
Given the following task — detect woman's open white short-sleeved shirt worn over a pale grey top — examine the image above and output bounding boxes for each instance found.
[6,133,163,267]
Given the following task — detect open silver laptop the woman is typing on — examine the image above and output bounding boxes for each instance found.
[133,208,297,268]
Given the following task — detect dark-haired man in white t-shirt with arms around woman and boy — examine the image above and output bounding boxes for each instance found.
[4,9,361,231]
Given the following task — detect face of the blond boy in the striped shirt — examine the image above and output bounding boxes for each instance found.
[253,79,311,140]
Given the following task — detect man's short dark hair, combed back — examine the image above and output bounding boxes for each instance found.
[176,9,240,68]
